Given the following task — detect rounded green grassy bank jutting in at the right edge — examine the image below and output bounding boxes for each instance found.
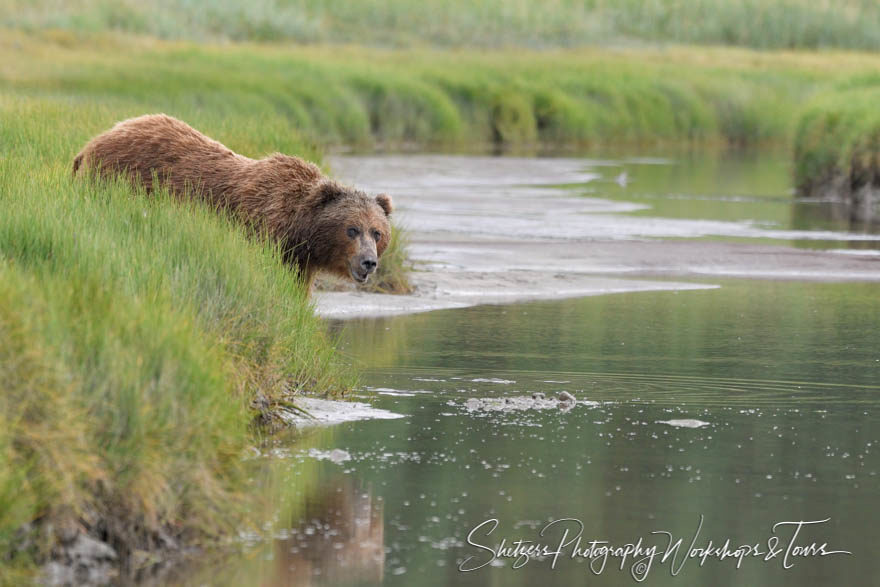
[794,81,880,220]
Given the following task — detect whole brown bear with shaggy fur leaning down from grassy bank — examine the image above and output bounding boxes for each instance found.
[73,114,391,289]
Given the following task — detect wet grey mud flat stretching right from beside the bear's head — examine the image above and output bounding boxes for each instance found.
[316,155,880,318]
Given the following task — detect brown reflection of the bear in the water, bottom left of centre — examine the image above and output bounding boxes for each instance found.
[264,477,385,586]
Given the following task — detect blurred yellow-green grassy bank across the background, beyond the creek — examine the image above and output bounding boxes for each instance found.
[8,32,880,152]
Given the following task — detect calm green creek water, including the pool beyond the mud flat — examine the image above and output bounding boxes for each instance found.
[193,156,880,586]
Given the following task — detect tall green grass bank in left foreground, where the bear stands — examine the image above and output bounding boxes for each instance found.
[0,95,353,583]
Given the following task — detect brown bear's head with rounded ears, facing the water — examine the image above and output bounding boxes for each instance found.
[294,180,391,283]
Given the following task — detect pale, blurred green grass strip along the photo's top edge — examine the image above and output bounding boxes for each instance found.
[0,0,880,50]
